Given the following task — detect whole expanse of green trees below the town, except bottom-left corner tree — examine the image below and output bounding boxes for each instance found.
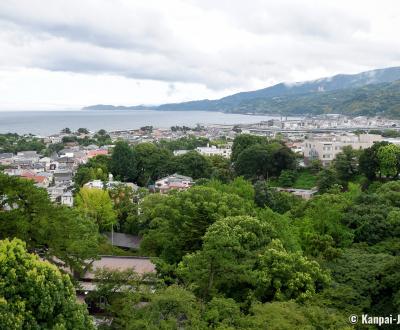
[7,133,400,330]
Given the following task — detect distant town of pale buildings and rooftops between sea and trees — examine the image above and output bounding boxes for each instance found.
[0,115,400,206]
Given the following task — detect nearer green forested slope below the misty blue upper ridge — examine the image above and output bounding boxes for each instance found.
[86,80,400,118]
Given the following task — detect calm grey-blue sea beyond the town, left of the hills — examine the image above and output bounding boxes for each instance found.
[0,110,278,135]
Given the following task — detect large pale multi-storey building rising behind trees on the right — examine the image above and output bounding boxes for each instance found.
[303,133,383,166]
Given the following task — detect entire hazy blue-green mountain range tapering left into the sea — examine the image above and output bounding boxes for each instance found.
[83,67,400,118]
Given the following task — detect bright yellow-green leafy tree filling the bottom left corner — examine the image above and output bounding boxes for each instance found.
[0,239,94,330]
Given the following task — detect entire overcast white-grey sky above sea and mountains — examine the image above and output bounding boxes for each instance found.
[0,0,400,110]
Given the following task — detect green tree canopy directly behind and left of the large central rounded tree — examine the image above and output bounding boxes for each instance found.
[139,187,253,263]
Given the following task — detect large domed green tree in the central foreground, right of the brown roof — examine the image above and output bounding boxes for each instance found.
[179,217,329,301]
